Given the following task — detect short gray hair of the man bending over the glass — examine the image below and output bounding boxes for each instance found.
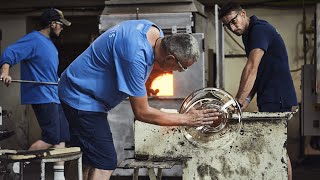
[161,33,200,62]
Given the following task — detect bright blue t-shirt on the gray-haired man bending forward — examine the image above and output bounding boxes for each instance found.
[59,20,163,112]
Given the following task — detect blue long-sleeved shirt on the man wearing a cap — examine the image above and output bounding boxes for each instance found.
[0,31,60,104]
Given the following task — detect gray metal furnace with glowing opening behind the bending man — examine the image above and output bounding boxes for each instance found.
[100,0,207,100]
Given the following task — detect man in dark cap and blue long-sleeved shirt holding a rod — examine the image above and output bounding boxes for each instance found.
[0,8,71,180]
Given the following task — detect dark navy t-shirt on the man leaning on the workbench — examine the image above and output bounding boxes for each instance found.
[242,16,297,107]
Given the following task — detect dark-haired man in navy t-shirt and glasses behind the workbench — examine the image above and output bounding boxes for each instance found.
[219,2,297,179]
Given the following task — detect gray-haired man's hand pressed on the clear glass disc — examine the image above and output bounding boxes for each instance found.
[186,109,221,127]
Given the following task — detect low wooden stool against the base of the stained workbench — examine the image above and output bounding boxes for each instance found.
[118,159,181,180]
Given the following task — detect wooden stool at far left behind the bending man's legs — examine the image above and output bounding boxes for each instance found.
[0,147,82,180]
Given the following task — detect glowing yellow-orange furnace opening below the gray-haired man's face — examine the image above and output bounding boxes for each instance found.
[151,73,173,96]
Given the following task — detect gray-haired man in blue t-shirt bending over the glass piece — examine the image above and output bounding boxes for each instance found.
[59,20,218,180]
